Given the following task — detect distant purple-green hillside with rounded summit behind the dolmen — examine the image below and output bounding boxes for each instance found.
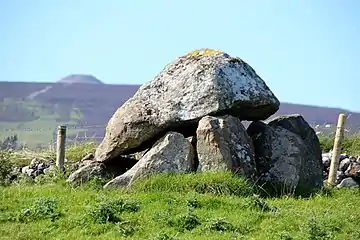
[0,79,360,148]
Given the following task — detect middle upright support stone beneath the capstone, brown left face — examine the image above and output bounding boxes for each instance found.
[196,115,257,180]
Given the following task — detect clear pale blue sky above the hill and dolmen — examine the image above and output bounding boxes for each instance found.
[0,0,360,111]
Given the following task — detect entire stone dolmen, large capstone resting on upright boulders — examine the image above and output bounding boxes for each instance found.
[68,49,323,195]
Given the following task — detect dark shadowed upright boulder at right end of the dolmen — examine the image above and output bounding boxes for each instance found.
[247,117,323,193]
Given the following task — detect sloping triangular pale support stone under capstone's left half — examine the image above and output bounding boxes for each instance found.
[104,132,195,188]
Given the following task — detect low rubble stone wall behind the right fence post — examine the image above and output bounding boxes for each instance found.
[322,151,360,188]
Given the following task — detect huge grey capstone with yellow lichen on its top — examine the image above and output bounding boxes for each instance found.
[95,50,280,162]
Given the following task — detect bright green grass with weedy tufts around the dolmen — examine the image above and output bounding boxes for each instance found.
[0,136,360,240]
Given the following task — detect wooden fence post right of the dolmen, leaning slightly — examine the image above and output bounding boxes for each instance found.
[328,113,345,186]
